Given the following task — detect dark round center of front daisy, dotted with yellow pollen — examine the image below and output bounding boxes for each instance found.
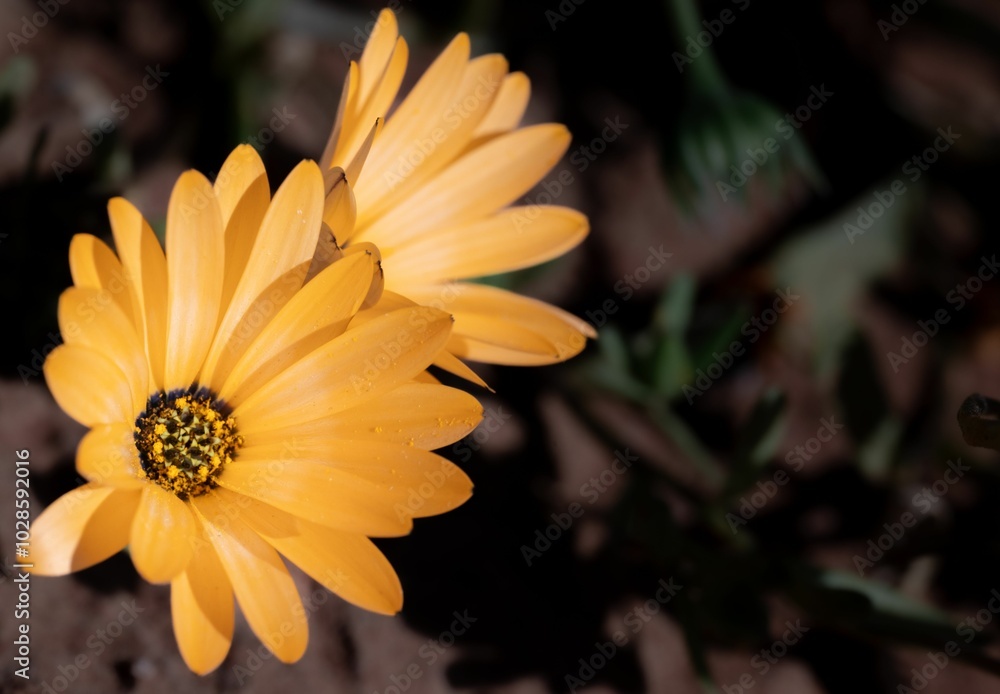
[135,389,243,499]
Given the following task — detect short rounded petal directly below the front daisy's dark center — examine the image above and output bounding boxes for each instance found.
[129,484,198,583]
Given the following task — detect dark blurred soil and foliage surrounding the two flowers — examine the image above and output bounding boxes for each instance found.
[0,0,1000,694]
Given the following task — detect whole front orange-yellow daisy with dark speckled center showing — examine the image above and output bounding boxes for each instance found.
[28,146,482,674]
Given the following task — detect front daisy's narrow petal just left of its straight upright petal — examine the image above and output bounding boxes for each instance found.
[108,198,167,389]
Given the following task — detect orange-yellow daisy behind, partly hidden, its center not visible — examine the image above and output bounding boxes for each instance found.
[320,10,596,381]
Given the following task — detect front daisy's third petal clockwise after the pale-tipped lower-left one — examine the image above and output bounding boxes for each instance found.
[59,287,150,413]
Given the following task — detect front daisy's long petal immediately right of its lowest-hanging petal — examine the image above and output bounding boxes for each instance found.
[192,493,309,663]
